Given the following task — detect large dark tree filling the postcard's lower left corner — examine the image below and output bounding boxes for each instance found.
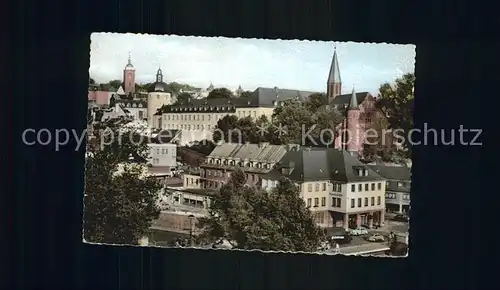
[83,119,161,244]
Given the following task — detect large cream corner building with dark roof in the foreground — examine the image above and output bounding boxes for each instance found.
[262,148,385,229]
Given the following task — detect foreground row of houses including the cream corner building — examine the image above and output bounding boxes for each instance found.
[162,143,411,228]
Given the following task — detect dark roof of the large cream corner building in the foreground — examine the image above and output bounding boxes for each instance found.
[263,148,385,182]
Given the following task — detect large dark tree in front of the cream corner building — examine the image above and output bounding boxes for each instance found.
[198,170,325,252]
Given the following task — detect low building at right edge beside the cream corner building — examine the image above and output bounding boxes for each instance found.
[370,165,411,213]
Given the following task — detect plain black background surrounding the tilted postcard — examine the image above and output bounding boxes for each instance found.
[5,0,490,289]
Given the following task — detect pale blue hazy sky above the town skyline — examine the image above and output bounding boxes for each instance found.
[89,33,415,94]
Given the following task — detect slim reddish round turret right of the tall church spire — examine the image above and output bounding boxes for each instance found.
[346,87,363,153]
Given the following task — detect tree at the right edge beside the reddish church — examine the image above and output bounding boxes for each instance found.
[376,73,415,156]
